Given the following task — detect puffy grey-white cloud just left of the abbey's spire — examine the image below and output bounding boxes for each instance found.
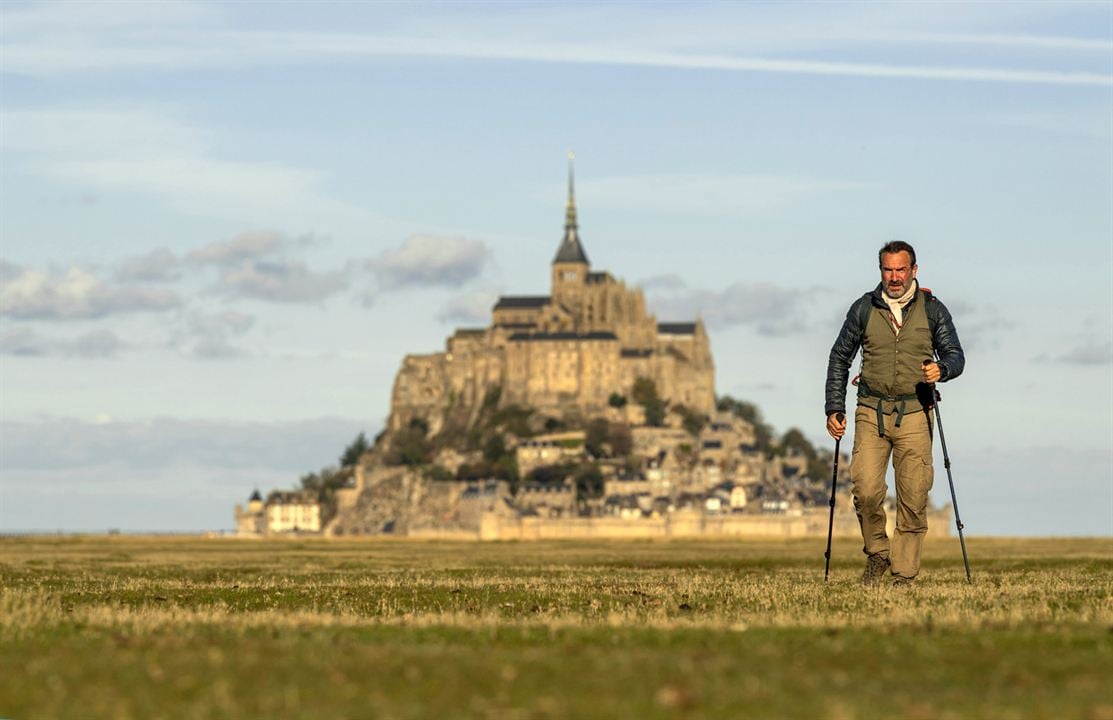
[367,235,491,289]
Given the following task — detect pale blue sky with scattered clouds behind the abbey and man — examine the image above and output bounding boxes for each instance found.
[0,0,1113,535]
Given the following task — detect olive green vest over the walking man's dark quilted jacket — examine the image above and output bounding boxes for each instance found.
[858,292,933,415]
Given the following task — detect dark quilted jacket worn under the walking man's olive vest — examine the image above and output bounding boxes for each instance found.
[824,283,966,415]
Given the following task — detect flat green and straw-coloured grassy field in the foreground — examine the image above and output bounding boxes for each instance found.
[0,537,1113,720]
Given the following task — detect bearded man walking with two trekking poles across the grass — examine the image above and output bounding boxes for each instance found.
[825,240,966,585]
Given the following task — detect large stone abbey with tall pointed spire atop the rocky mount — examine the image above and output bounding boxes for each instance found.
[388,159,716,433]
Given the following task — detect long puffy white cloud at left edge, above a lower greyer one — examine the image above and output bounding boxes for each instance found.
[0,266,180,319]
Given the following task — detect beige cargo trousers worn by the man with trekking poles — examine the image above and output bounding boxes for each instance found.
[850,405,935,579]
